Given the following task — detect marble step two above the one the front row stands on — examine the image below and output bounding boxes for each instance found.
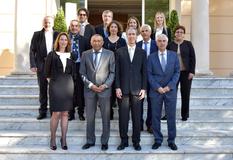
[0,117,233,131]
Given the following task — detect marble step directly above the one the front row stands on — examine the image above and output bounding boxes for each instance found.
[0,130,233,147]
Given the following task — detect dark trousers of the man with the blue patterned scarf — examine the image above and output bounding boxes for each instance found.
[72,63,85,115]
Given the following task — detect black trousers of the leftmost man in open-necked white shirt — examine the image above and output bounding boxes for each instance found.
[37,71,48,114]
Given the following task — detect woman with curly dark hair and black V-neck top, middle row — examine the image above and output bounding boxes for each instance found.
[103,20,126,120]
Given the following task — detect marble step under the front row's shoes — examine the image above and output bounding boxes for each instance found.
[0,144,233,160]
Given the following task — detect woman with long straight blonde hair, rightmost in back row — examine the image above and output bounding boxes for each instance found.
[151,12,171,42]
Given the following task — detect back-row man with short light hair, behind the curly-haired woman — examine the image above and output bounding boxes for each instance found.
[95,10,113,38]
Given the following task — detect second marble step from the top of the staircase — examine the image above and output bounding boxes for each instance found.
[0,85,233,97]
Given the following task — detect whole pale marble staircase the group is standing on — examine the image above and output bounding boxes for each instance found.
[0,75,233,160]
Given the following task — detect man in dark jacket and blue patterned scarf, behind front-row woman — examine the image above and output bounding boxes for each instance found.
[69,19,90,121]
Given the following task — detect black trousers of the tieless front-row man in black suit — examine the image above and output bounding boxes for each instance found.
[118,94,141,143]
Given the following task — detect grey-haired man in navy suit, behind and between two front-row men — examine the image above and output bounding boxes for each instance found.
[137,24,158,133]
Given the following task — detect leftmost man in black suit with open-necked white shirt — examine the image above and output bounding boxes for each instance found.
[29,16,58,120]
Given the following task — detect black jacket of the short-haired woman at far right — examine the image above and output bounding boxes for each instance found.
[167,40,196,74]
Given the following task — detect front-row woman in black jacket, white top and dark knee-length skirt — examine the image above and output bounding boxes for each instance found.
[45,32,75,150]
